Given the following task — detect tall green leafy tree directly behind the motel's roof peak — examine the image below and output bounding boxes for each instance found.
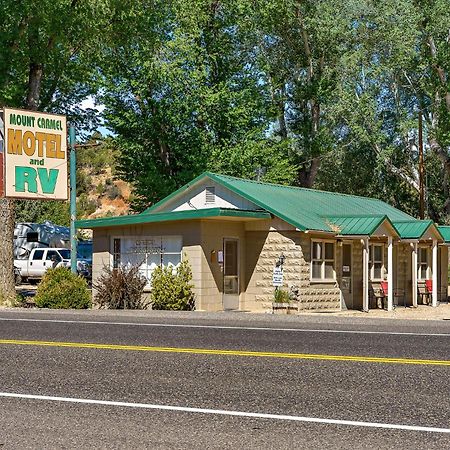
[102,0,291,210]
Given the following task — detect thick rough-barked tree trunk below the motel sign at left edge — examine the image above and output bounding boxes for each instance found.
[0,198,16,304]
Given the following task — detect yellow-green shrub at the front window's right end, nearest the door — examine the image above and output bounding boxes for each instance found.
[151,260,194,311]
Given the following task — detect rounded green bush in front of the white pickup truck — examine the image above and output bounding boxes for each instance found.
[34,267,91,309]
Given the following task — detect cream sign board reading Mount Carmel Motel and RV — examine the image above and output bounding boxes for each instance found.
[3,108,68,200]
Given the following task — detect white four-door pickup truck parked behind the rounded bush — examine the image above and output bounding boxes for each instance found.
[14,248,91,281]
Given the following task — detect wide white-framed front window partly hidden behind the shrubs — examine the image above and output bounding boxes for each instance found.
[112,236,182,285]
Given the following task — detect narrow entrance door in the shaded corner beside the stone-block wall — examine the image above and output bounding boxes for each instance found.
[223,239,239,309]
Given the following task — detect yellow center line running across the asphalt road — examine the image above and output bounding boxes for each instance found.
[0,339,450,366]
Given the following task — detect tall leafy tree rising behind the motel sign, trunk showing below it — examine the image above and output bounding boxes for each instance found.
[0,0,128,300]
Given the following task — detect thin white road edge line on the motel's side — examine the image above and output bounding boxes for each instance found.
[0,317,450,337]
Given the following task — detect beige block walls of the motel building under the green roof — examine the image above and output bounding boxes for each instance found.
[89,218,448,311]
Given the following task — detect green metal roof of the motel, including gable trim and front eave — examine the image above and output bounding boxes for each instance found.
[86,172,442,237]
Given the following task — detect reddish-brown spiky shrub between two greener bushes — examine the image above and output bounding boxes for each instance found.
[93,266,147,309]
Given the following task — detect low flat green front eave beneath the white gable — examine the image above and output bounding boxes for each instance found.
[75,208,271,228]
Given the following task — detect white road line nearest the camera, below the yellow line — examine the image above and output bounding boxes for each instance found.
[0,392,450,433]
